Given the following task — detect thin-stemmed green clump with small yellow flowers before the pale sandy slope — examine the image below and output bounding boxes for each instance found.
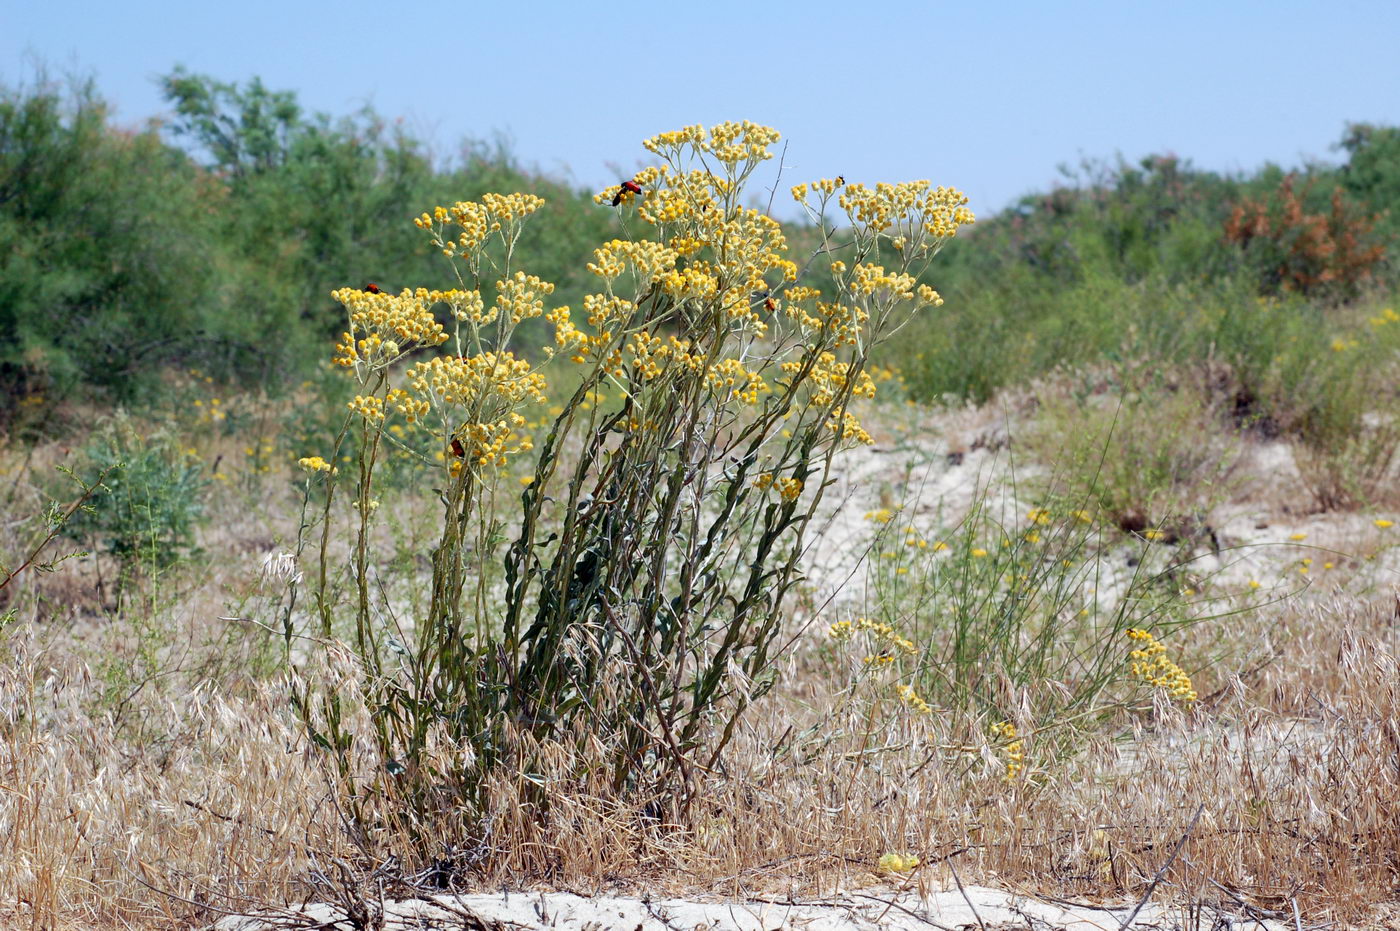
[827,478,1211,774]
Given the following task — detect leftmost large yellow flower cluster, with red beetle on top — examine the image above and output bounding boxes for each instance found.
[330,288,447,368]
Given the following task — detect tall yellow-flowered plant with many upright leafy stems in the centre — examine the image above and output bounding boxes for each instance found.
[298,122,973,840]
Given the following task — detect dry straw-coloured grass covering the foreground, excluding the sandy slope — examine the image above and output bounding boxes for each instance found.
[0,389,1400,928]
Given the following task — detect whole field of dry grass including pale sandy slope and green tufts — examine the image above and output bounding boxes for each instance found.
[0,347,1400,927]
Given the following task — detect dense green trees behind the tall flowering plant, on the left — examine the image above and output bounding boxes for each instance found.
[0,70,616,402]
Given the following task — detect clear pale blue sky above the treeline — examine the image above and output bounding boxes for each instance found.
[0,0,1400,211]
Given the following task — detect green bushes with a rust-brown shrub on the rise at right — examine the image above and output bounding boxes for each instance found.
[895,123,1400,400]
